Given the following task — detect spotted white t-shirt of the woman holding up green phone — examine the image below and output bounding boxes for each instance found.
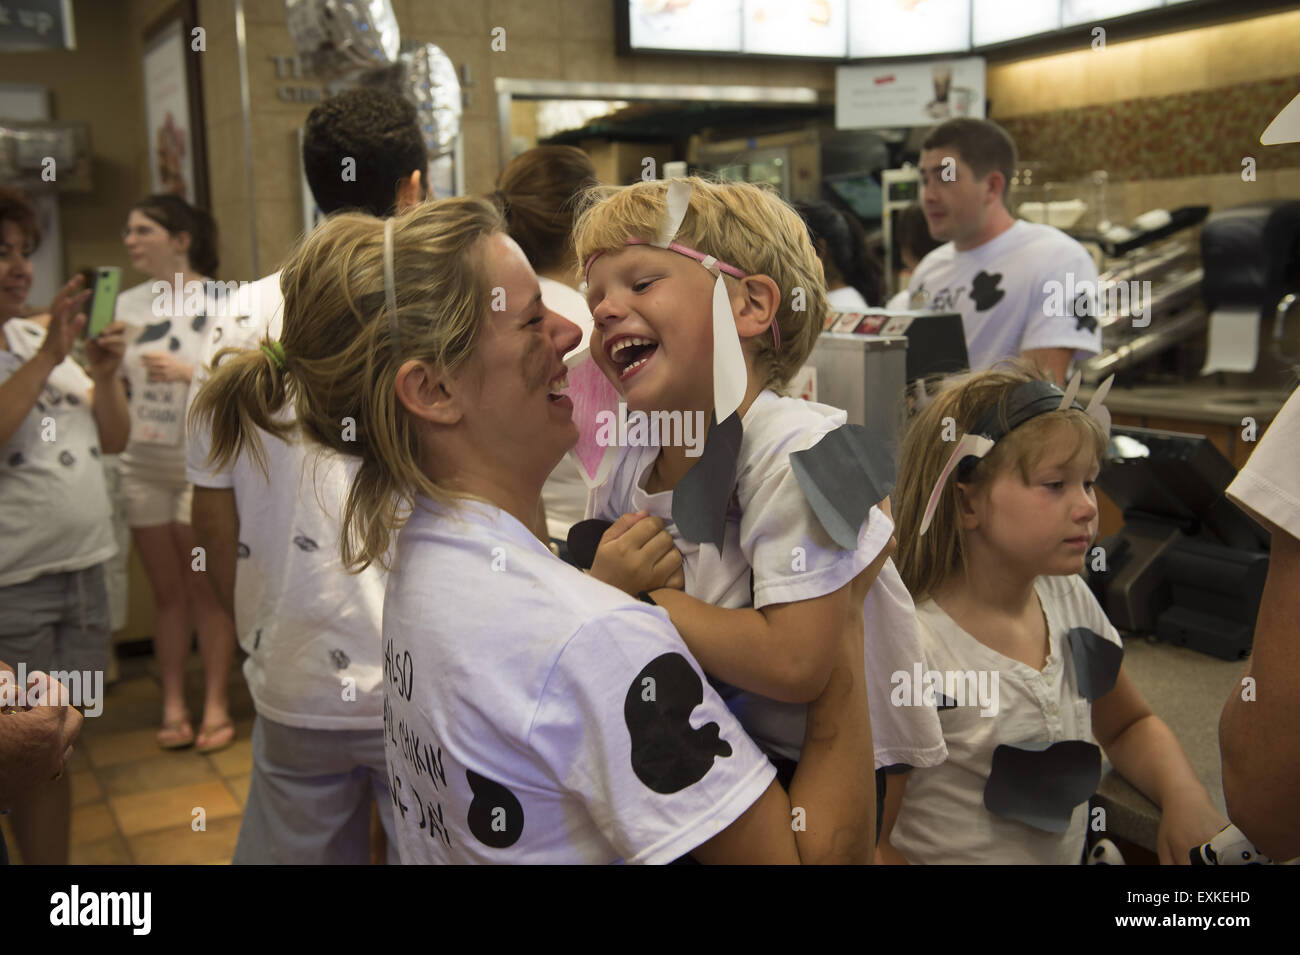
[0,318,117,587]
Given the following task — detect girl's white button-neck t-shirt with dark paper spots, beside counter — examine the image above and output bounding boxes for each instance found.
[889,574,1123,865]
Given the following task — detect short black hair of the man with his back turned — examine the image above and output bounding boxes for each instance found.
[303,87,429,218]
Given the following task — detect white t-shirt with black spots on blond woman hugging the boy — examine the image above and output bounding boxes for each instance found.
[384,500,776,864]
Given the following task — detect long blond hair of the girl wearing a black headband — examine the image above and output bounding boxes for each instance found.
[892,359,1106,603]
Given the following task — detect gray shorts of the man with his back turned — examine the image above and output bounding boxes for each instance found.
[231,716,399,865]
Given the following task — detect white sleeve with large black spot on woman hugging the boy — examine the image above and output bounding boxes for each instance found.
[528,607,776,863]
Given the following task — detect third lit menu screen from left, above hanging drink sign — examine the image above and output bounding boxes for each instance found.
[849,0,971,57]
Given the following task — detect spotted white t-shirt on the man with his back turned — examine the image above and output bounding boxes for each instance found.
[186,275,385,730]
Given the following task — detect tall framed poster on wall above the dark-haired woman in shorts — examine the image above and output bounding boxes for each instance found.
[144,0,208,208]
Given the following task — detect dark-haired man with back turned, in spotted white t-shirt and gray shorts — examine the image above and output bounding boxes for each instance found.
[187,88,428,864]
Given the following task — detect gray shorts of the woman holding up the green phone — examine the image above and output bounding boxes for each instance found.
[0,564,112,673]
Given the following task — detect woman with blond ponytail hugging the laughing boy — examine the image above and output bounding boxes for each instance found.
[194,197,874,863]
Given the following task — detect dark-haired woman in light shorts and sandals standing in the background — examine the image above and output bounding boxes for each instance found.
[117,195,235,752]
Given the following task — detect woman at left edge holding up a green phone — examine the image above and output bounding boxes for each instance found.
[0,188,130,865]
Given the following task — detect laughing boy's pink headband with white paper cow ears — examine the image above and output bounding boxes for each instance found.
[582,179,781,422]
